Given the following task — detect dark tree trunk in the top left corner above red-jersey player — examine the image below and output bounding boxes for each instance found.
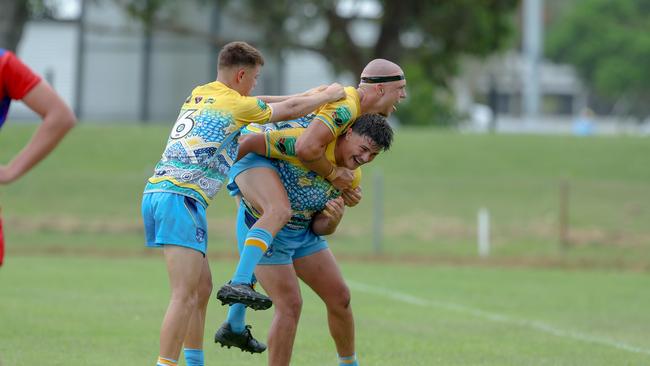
[0,0,29,52]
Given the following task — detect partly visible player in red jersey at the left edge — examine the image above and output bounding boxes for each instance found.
[0,48,76,265]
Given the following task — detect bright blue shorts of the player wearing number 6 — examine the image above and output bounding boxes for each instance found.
[142,192,208,256]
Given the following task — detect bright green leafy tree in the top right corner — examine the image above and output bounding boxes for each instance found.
[546,0,650,120]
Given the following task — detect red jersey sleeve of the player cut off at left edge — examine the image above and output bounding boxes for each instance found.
[0,51,41,99]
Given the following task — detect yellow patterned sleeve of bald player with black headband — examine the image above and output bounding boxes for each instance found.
[316,86,361,136]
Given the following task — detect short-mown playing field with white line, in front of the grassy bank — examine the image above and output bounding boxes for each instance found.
[0,256,650,366]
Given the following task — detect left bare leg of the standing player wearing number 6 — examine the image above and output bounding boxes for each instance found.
[160,245,205,360]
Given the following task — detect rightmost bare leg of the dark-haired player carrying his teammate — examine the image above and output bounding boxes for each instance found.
[293,249,355,356]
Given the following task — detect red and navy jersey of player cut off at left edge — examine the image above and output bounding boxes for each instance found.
[0,48,41,127]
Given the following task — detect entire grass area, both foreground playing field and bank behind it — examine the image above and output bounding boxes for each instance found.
[0,124,650,366]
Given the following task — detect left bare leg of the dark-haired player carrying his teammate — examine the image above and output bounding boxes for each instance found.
[255,264,302,366]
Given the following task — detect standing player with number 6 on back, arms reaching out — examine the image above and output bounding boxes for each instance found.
[142,42,344,366]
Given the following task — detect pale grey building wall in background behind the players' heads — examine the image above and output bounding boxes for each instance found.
[9,1,350,123]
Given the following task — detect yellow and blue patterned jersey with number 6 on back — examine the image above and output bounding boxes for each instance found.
[144,81,272,206]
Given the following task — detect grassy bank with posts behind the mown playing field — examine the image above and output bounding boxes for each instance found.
[5,124,650,267]
